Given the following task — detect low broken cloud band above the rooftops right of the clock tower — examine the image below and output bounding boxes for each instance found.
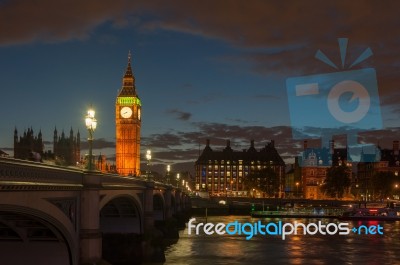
[140,120,400,174]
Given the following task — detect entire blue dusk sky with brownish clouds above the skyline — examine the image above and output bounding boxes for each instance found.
[0,0,400,173]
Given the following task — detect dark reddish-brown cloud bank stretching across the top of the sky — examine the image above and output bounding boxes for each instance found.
[0,0,400,110]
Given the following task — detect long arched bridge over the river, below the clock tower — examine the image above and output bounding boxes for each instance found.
[0,158,190,265]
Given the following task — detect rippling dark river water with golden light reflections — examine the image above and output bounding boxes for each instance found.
[165,216,400,265]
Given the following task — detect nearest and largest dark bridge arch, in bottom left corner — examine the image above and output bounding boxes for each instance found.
[0,204,79,265]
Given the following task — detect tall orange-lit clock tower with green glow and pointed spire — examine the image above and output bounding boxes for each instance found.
[115,52,141,176]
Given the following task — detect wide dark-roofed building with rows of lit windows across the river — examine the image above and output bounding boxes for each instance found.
[195,140,285,197]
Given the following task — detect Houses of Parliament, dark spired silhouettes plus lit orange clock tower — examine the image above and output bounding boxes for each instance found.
[14,52,142,176]
